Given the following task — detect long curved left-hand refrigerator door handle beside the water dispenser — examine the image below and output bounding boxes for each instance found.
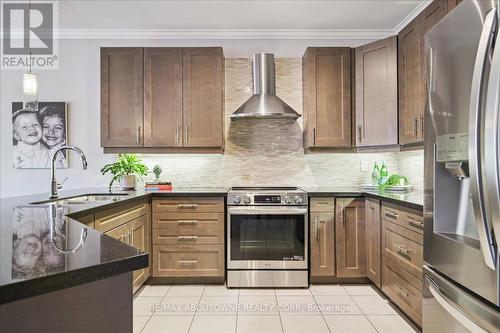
[469,8,497,270]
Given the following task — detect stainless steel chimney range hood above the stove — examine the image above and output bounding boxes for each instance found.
[230,53,300,120]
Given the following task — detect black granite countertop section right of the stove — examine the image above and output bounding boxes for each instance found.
[303,187,424,210]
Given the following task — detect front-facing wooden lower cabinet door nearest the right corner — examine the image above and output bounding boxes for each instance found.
[335,198,366,278]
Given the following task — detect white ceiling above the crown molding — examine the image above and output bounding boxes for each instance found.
[59,0,428,38]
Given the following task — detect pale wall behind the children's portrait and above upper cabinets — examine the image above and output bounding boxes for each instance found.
[0,40,424,197]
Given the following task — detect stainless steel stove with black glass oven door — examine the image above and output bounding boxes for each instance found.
[227,187,309,288]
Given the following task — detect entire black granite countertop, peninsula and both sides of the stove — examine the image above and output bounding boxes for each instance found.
[0,187,423,304]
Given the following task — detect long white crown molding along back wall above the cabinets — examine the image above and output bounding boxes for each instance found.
[59,29,394,40]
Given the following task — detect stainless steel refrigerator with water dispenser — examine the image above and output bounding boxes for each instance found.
[422,0,500,333]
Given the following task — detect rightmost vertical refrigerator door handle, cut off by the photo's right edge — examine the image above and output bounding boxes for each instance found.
[484,11,500,245]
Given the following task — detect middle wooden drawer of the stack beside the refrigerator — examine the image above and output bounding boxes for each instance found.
[382,220,424,277]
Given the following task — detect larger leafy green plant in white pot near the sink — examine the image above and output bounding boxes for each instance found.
[101,154,148,190]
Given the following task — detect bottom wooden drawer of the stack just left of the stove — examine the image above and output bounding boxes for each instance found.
[152,245,224,277]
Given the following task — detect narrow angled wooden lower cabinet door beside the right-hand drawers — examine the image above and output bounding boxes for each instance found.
[365,198,382,288]
